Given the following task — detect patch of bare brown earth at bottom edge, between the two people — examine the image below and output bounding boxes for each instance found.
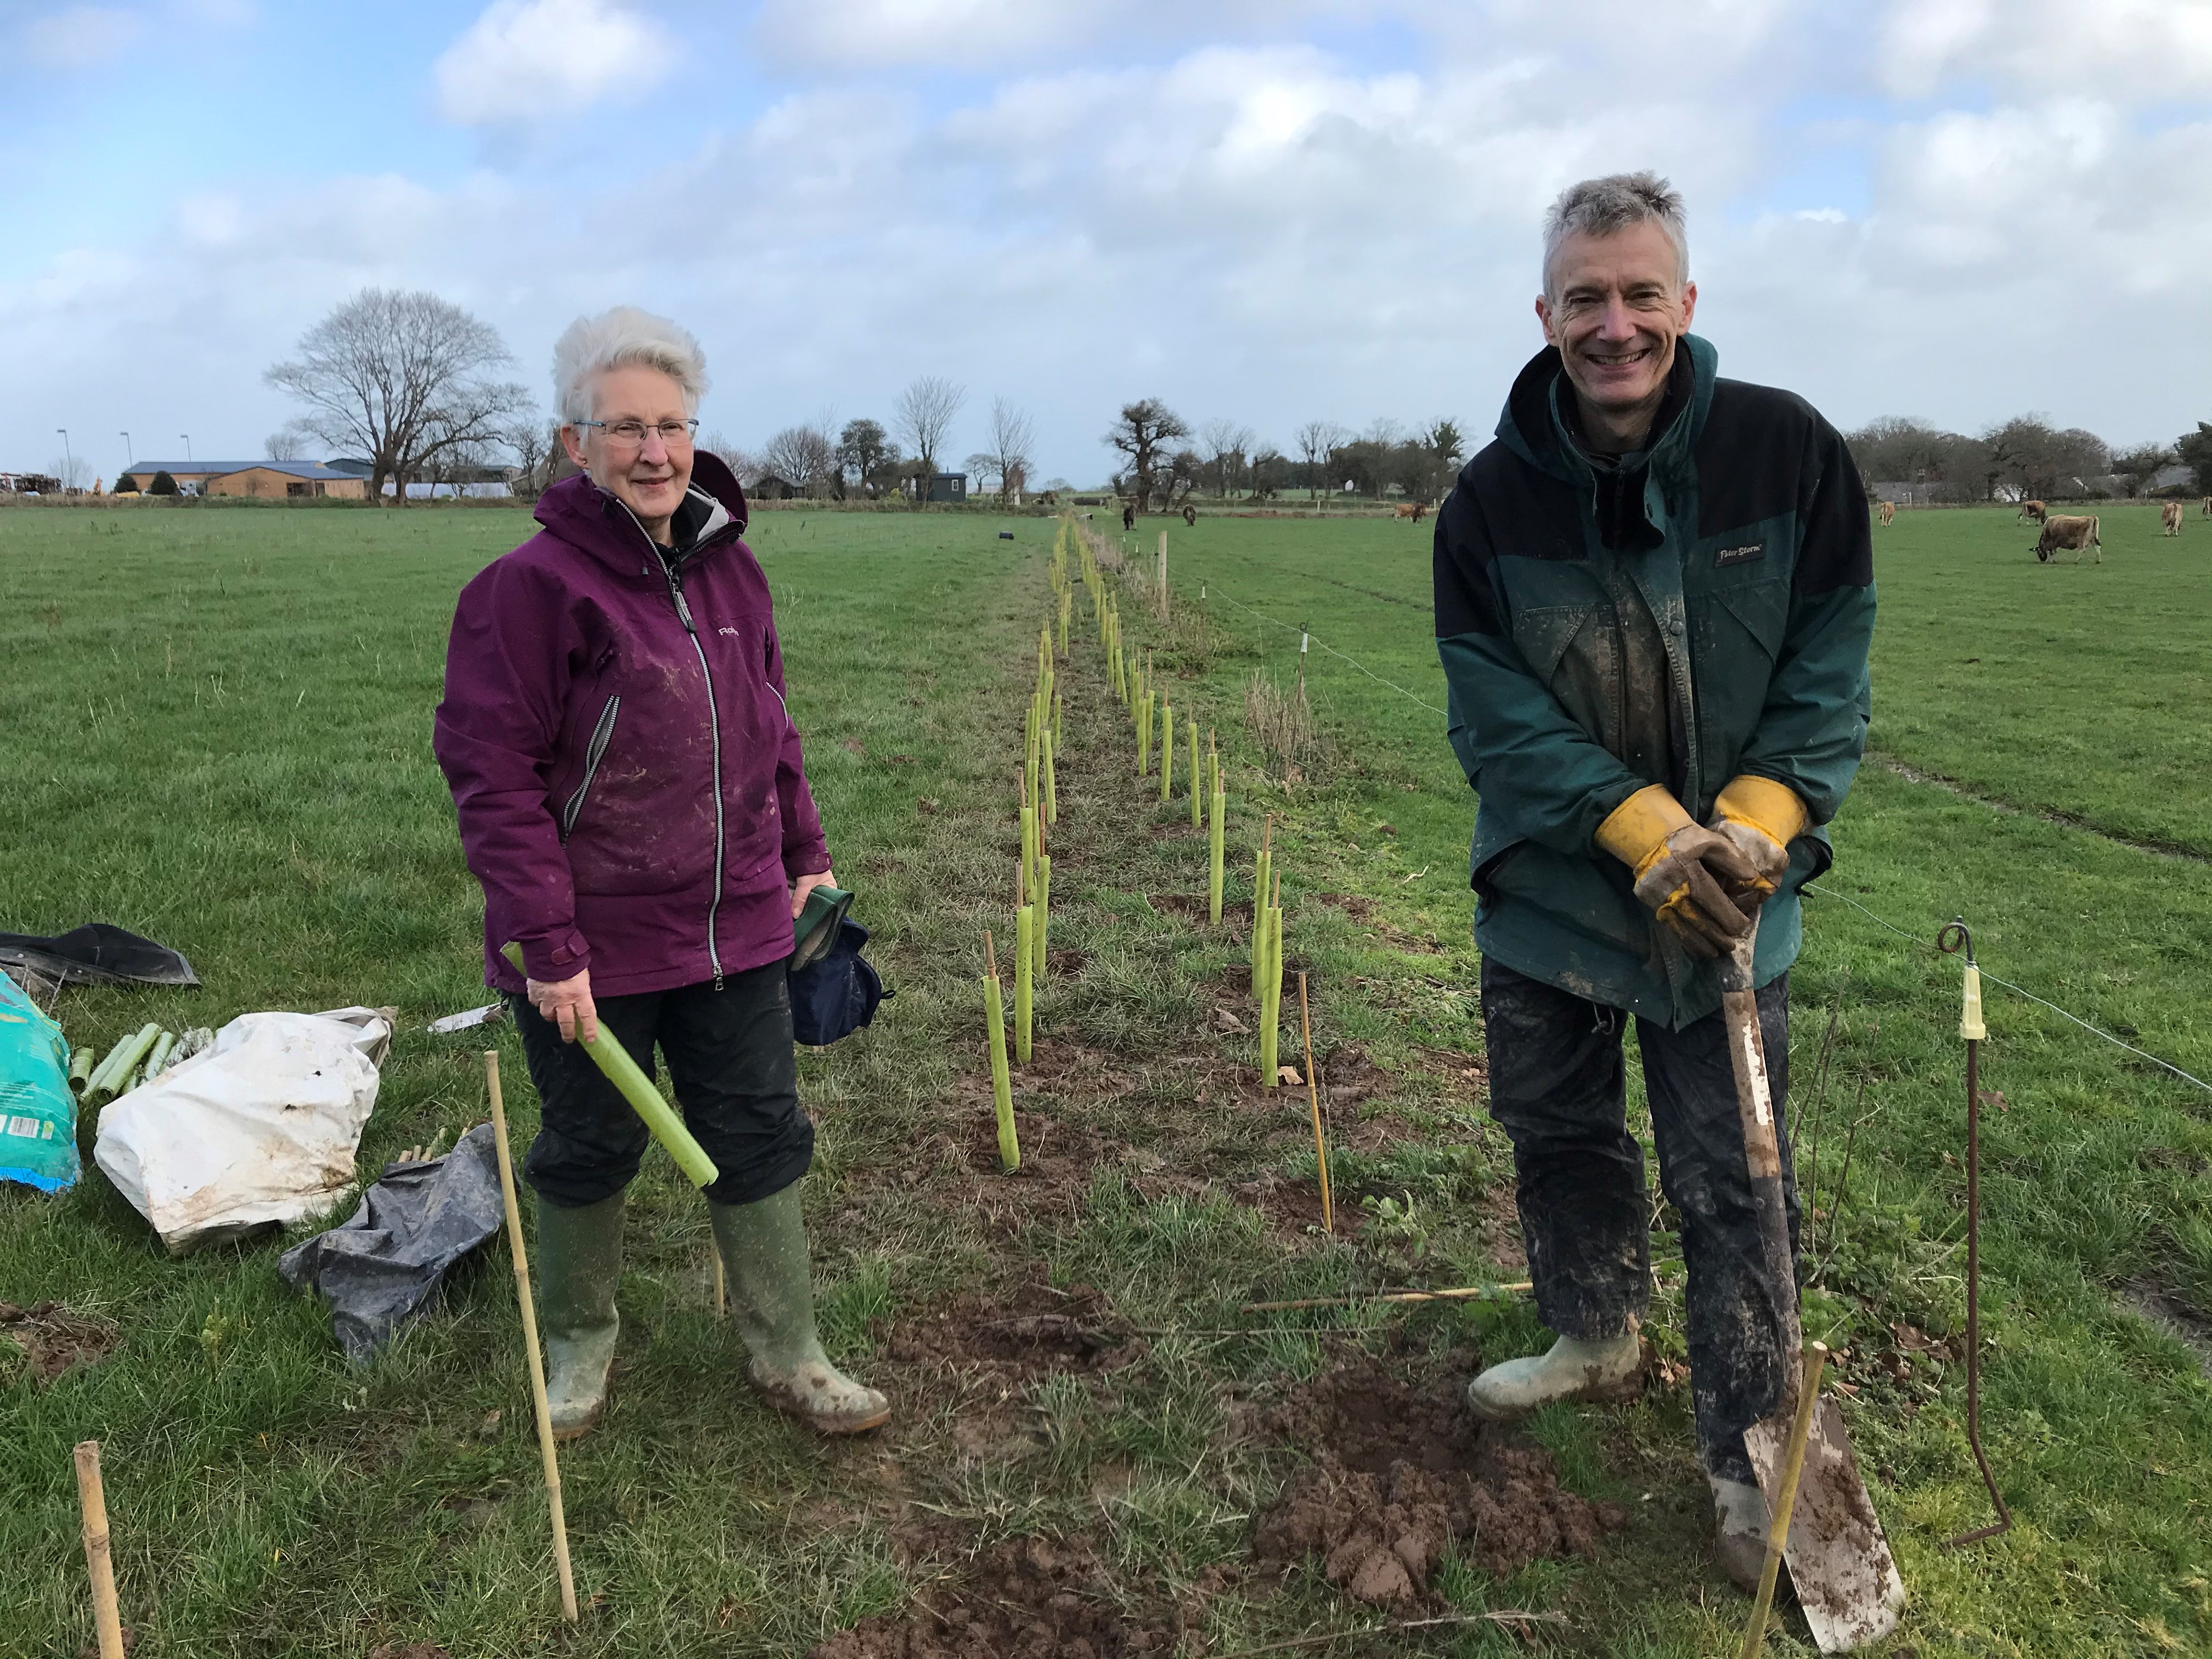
[808,1537,1181,1659]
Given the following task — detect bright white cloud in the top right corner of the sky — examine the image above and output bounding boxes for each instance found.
[1876,0,2212,101]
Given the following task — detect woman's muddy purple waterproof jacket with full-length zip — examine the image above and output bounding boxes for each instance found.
[433,452,830,995]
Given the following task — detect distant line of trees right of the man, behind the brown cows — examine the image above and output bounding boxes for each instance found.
[1845,414,2212,502]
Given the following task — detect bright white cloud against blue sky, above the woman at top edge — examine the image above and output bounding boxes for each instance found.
[431,0,677,126]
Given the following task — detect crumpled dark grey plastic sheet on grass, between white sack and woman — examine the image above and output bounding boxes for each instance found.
[276,1124,506,1365]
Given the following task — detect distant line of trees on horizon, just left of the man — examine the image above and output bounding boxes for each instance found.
[1104,398,1466,513]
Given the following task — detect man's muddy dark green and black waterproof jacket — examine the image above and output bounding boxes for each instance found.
[1436,334,1874,1029]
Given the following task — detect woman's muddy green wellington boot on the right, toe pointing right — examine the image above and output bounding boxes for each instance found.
[706,1181,891,1434]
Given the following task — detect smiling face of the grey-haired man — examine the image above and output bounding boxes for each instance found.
[1535,221,1697,414]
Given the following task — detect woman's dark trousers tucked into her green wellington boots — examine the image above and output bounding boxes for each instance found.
[509,962,814,1207]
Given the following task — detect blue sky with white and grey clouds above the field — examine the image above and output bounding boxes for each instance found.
[0,0,2212,482]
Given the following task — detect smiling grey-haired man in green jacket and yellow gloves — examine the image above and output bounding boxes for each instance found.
[1436,172,1874,1590]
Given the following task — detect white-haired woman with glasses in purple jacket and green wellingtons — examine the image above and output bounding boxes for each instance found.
[436,307,889,1438]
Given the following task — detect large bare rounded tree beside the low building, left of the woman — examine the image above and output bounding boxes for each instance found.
[261,287,529,502]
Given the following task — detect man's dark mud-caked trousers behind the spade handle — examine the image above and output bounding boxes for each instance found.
[1482,958,1798,1480]
